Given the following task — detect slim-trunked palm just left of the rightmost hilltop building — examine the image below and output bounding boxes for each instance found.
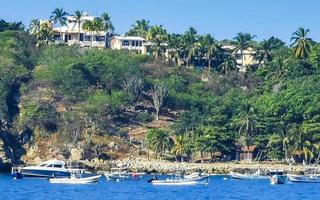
[200,34,222,73]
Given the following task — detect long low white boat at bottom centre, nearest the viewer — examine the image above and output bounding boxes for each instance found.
[151,178,208,186]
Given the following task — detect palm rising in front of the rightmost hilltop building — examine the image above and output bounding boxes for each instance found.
[232,32,256,72]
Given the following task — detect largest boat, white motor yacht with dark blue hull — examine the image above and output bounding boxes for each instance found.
[21,159,85,178]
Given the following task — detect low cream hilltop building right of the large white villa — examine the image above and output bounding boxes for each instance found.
[109,36,147,54]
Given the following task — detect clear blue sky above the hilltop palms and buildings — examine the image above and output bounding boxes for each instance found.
[0,0,320,42]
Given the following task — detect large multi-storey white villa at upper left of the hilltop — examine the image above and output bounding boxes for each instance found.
[53,13,107,48]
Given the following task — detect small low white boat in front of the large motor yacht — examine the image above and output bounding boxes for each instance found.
[49,174,101,184]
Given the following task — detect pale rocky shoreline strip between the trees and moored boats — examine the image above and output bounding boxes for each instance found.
[84,158,320,175]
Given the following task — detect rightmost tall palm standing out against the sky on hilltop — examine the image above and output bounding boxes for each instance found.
[290,27,312,60]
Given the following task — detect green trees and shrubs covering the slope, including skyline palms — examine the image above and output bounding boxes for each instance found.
[0,16,320,166]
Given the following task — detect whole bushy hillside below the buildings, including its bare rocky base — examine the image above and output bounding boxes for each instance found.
[0,27,320,170]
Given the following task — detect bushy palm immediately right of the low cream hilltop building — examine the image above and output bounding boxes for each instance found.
[147,25,168,58]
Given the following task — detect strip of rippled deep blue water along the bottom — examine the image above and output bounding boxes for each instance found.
[0,174,320,200]
